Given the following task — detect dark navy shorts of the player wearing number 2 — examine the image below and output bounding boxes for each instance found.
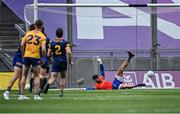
[51,61,67,72]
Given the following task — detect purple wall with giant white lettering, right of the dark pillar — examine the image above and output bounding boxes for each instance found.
[73,0,180,50]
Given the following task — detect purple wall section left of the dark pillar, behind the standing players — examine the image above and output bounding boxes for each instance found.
[3,0,67,39]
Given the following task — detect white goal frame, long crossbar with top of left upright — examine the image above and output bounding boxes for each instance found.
[24,0,180,24]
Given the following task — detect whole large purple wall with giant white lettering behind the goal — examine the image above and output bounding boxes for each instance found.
[4,0,180,50]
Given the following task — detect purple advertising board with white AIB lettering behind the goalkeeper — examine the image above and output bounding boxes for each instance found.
[106,71,180,88]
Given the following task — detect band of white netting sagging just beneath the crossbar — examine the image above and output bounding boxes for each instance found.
[24,5,180,23]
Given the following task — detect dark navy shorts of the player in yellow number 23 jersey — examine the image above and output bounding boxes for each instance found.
[23,57,41,67]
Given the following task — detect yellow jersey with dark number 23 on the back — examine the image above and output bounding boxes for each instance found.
[23,30,46,59]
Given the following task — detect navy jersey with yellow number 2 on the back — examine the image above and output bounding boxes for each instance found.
[50,39,69,63]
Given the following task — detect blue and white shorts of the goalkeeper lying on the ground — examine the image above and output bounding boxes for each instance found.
[112,75,123,89]
